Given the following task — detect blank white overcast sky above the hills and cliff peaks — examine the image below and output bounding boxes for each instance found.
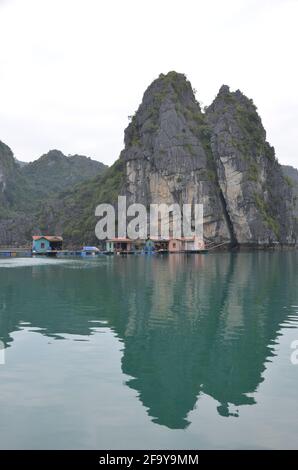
[0,0,298,167]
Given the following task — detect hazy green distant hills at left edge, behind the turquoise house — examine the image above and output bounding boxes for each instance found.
[0,141,107,246]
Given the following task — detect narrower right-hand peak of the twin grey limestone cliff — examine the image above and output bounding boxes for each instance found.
[206,86,294,245]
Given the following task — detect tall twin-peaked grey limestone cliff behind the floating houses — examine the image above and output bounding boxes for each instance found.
[120,72,295,245]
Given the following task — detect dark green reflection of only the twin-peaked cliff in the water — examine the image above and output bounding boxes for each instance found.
[116,255,296,428]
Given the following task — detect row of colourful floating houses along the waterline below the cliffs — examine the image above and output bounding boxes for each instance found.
[0,235,215,258]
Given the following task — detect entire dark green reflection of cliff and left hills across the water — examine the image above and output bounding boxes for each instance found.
[0,253,295,429]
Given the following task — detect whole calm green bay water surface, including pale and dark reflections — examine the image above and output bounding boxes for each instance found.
[0,252,298,449]
